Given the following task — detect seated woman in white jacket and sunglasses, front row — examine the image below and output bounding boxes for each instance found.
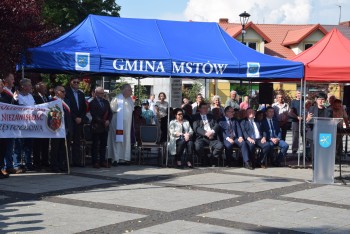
[169,108,193,168]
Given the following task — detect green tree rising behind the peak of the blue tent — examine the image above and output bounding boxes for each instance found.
[42,0,121,32]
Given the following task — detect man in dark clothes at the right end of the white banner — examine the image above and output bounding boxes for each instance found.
[50,86,72,173]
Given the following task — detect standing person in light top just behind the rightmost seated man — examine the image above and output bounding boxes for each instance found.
[272,94,289,141]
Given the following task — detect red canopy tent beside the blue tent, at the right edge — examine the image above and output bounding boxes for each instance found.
[291,28,350,83]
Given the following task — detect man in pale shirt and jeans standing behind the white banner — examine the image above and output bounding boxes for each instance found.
[13,78,35,171]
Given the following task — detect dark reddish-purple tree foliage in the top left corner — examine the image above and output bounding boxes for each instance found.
[0,0,57,75]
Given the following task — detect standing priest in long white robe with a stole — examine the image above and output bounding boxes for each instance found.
[108,84,134,166]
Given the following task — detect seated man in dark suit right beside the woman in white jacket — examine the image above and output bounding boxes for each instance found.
[193,103,224,165]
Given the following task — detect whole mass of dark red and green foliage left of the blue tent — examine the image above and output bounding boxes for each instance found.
[0,0,120,76]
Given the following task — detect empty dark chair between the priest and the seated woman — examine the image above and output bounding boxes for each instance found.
[138,125,165,166]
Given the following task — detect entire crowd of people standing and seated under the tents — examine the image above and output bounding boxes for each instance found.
[0,73,349,178]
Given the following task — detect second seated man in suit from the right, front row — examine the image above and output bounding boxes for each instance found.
[241,107,271,168]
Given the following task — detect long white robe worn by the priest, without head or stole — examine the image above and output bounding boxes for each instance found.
[108,95,134,162]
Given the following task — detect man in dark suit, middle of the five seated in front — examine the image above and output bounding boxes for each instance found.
[219,106,253,170]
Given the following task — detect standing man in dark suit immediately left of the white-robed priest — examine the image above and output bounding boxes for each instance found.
[90,87,112,169]
